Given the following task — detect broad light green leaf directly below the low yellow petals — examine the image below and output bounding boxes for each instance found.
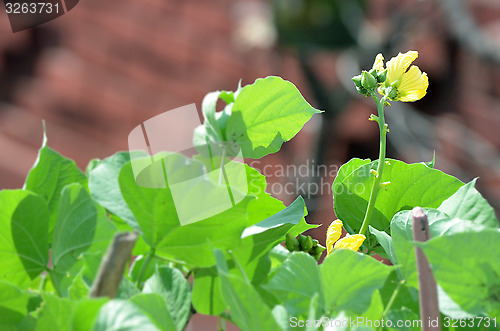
[320,249,394,313]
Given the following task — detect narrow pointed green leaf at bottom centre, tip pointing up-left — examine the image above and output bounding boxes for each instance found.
[214,250,281,330]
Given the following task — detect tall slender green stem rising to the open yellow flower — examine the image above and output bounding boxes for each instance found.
[359,97,387,234]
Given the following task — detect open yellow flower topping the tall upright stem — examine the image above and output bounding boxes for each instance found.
[380,51,429,102]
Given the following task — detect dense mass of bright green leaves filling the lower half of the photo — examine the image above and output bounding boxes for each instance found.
[0,77,500,331]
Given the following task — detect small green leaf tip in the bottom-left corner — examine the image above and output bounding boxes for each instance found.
[0,280,34,330]
